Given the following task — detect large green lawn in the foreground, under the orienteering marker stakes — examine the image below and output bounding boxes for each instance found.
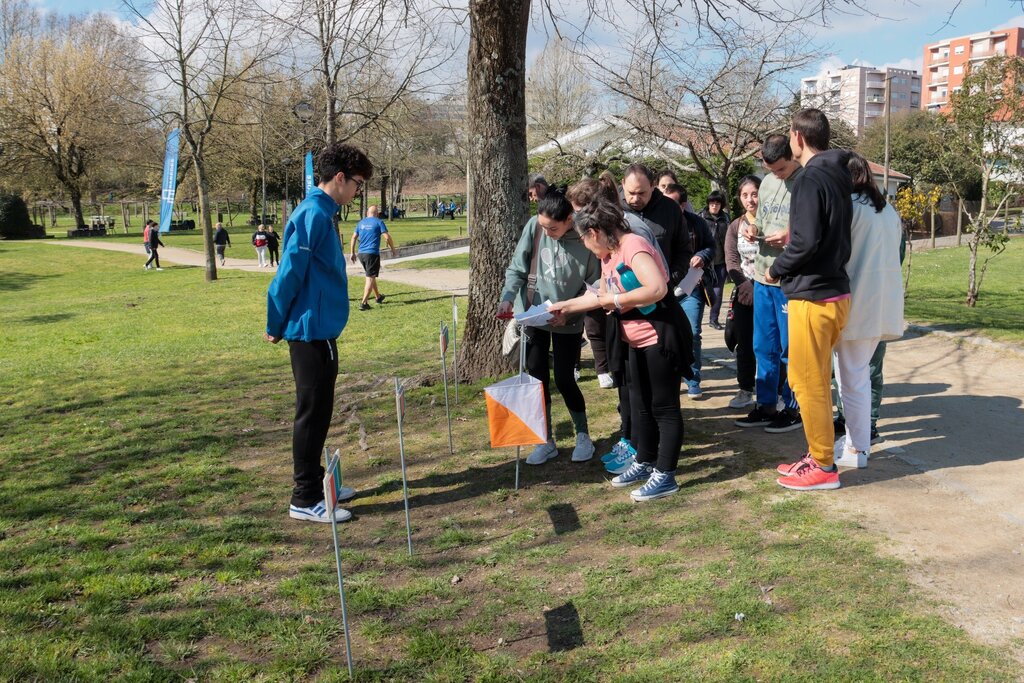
[0,242,1019,683]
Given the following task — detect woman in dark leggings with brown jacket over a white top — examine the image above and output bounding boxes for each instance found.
[723,175,761,410]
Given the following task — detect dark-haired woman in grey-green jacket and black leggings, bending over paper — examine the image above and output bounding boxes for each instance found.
[497,189,600,465]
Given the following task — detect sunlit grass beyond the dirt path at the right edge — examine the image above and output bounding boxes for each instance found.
[905,238,1024,343]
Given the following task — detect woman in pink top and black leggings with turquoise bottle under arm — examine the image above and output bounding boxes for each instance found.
[550,199,692,501]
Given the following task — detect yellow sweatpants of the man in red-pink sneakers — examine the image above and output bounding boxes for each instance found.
[788,299,850,467]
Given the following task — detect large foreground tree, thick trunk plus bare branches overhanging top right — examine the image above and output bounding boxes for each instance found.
[460,0,876,379]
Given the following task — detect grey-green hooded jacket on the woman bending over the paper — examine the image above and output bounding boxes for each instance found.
[502,216,601,334]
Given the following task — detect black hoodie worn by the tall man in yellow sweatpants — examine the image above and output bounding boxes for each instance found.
[768,150,853,301]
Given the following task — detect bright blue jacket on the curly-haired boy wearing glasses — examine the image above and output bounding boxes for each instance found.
[266,187,348,342]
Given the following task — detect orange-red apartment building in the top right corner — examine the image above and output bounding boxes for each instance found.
[921,29,1024,112]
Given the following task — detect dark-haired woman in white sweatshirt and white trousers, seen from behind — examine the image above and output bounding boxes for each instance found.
[835,154,903,467]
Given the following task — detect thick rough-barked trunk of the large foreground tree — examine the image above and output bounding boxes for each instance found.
[459,0,529,381]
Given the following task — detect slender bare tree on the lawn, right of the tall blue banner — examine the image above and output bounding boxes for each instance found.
[125,0,284,281]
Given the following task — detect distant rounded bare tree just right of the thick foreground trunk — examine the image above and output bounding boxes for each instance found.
[526,38,596,144]
